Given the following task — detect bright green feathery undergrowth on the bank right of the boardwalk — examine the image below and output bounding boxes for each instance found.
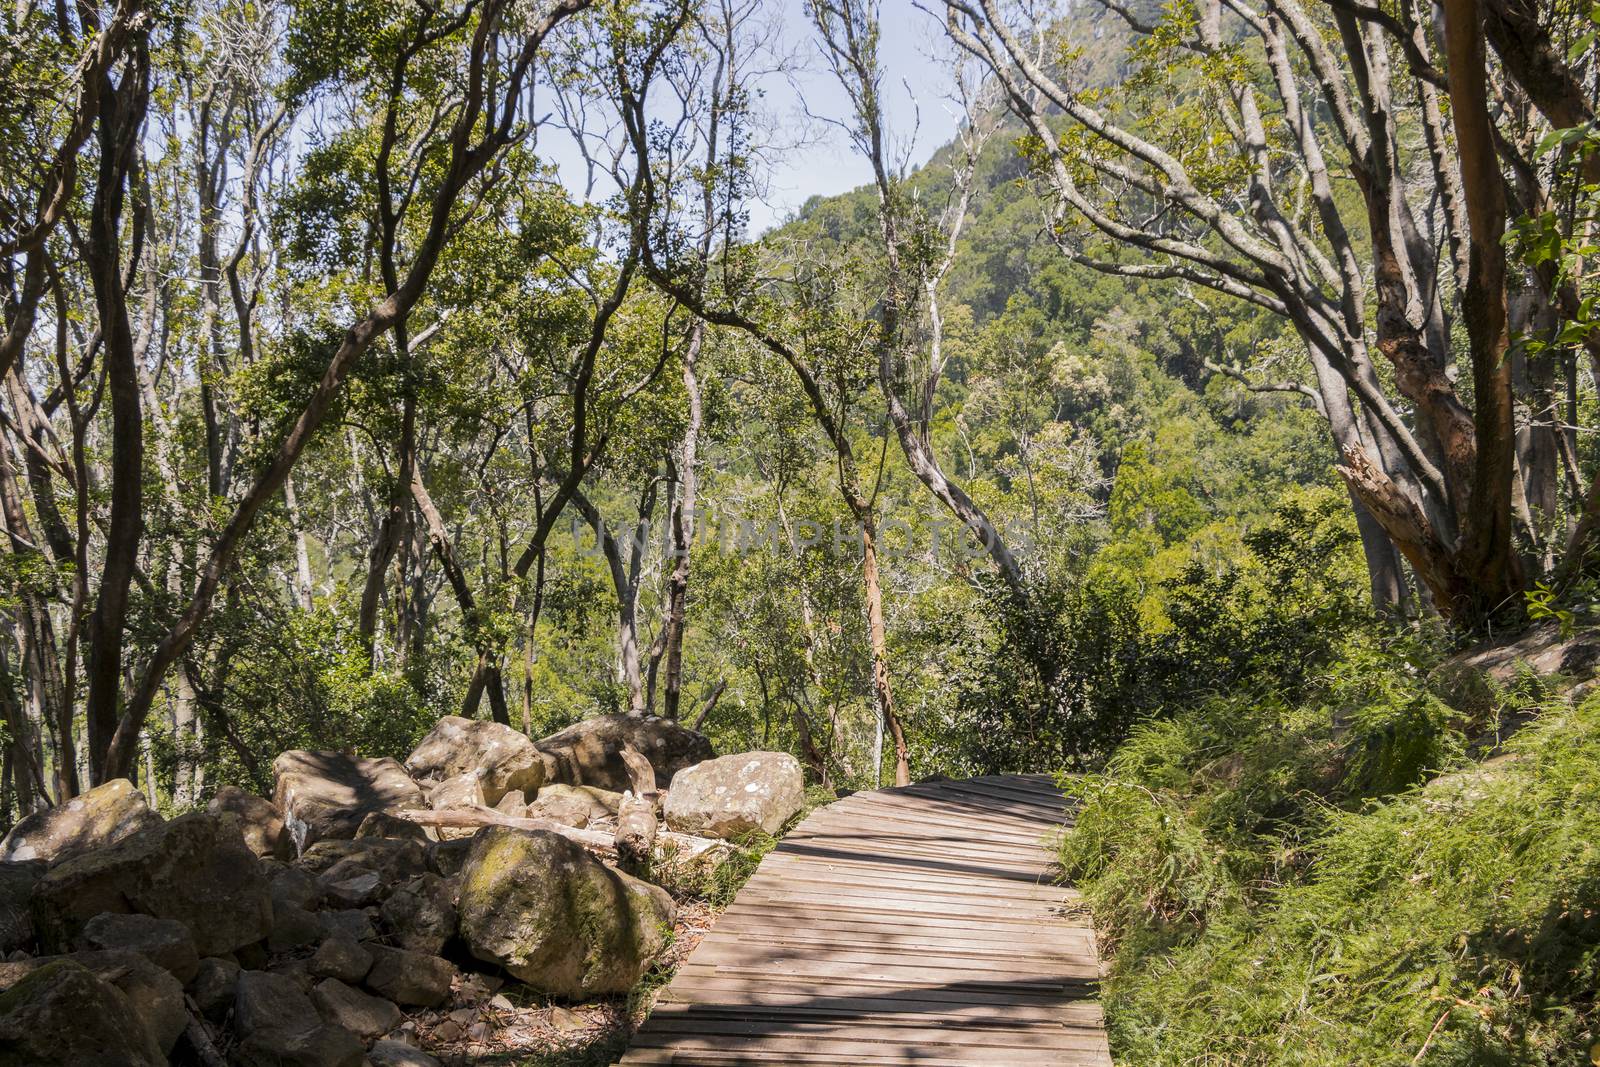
[1061,633,1600,1067]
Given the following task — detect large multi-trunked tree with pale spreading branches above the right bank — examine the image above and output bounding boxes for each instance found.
[946,0,1550,625]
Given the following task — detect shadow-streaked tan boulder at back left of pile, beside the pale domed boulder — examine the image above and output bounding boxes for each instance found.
[272,750,427,853]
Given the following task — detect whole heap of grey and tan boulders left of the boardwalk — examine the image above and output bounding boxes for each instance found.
[0,717,803,1067]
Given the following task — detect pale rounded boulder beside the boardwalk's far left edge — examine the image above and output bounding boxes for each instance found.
[662,752,805,838]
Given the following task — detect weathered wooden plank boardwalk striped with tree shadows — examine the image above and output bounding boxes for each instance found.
[619,774,1110,1067]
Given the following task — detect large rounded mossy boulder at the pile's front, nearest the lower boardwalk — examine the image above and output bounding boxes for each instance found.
[459,827,674,1000]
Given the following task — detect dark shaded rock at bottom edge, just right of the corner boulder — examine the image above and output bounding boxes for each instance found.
[234,971,365,1067]
